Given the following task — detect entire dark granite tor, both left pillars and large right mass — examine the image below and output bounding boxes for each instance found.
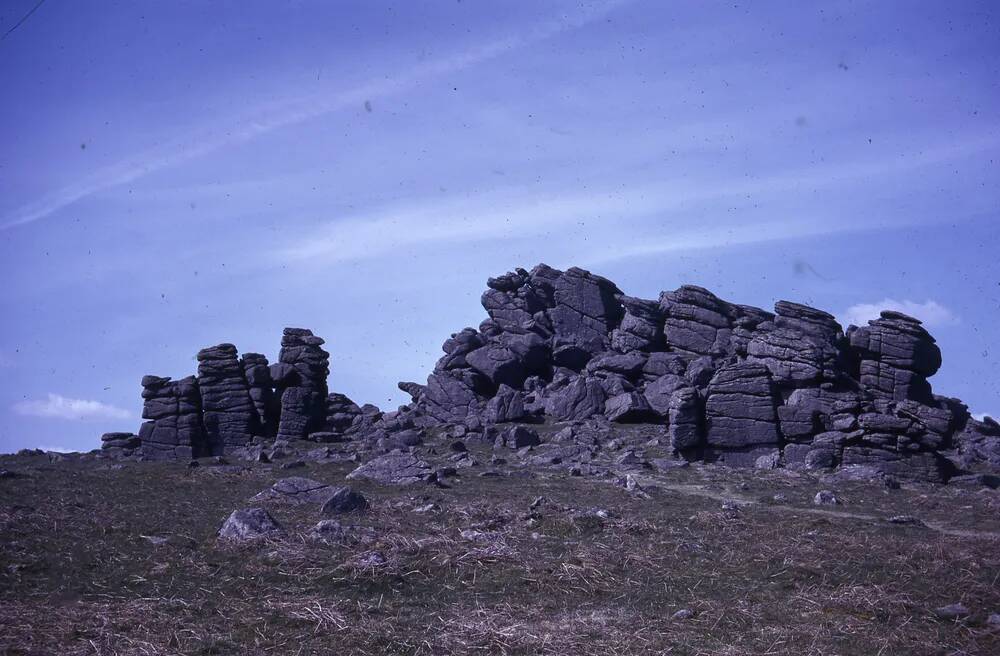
[127,264,1000,481]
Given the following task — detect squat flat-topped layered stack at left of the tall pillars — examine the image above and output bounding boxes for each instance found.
[139,376,205,460]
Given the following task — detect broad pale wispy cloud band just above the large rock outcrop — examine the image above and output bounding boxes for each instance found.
[272,133,986,270]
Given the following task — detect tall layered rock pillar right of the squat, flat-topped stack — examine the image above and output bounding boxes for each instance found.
[198,344,260,456]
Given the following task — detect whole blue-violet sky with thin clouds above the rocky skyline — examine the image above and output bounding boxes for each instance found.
[0,0,1000,452]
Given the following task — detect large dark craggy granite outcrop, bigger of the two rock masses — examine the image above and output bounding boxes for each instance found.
[405,264,1000,480]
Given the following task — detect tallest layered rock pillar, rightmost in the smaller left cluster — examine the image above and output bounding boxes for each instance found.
[272,328,330,440]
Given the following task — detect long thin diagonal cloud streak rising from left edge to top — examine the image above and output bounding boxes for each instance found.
[0,0,630,230]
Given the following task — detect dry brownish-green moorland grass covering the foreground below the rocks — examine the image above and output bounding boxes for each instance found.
[0,430,1000,656]
